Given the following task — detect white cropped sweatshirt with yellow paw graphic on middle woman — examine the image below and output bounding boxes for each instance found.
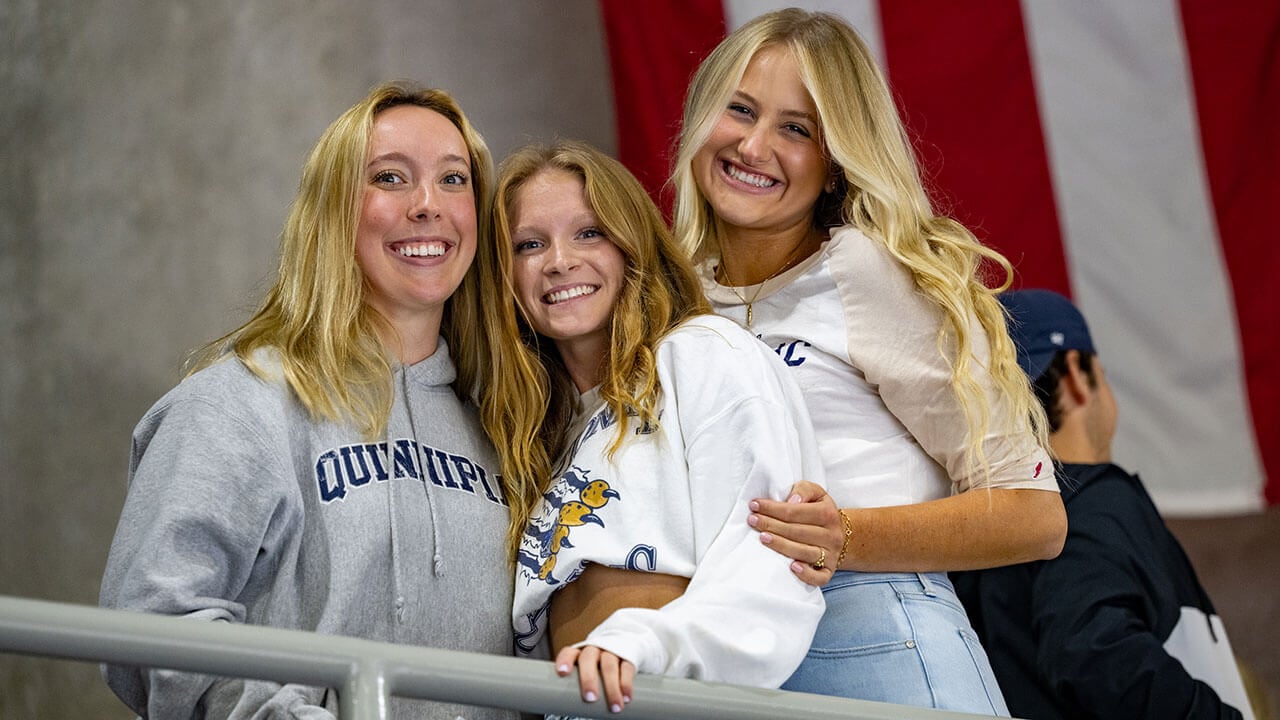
[512,315,824,687]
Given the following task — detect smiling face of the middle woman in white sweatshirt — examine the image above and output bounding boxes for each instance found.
[511,169,626,389]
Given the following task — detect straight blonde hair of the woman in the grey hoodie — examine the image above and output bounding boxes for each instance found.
[187,81,493,439]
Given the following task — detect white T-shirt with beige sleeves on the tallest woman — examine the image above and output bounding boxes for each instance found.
[699,227,1057,507]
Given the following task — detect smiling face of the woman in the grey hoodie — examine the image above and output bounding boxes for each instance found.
[356,105,476,353]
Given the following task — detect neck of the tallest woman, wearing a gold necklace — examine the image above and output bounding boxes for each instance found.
[717,222,824,287]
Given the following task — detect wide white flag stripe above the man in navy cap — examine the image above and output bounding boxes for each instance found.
[1023,0,1263,515]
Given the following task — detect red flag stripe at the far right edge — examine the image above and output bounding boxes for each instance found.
[1180,0,1280,505]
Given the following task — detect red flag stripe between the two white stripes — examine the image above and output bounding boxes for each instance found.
[879,0,1071,295]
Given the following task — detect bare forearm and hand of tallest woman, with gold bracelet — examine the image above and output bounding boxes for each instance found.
[748,482,1066,584]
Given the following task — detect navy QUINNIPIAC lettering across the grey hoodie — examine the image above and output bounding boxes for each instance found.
[316,438,507,506]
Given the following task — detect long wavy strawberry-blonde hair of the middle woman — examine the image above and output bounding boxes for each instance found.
[476,141,710,553]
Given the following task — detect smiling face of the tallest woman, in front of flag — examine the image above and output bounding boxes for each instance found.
[692,45,829,236]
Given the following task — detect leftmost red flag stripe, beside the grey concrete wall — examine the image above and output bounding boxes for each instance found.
[600,0,724,209]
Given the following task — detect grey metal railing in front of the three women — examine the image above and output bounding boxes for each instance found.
[0,596,998,720]
